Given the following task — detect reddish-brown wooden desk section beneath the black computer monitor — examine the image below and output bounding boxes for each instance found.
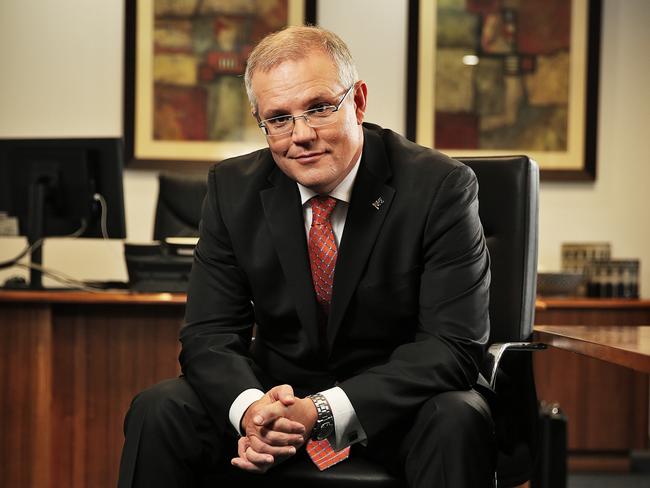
[0,291,185,488]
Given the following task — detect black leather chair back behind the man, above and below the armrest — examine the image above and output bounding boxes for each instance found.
[458,156,539,486]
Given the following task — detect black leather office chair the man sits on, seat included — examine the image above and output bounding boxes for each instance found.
[203,156,539,488]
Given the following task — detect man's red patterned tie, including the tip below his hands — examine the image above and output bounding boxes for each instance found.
[307,196,350,471]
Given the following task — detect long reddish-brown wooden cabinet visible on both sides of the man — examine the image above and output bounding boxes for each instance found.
[0,291,650,488]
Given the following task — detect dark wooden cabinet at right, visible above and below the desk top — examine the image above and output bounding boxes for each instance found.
[534,298,650,469]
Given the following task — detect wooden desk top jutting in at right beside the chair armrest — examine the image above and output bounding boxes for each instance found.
[535,325,650,373]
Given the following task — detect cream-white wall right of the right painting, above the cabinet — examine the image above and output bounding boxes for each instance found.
[540,0,650,282]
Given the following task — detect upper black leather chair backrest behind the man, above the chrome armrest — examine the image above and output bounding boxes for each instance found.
[457,156,539,343]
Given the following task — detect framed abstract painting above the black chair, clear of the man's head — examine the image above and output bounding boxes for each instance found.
[407,0,601,180]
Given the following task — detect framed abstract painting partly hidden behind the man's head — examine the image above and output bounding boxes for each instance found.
[124,0,316,168]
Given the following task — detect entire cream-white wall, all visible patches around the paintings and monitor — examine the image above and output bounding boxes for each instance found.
[0,0,650,298]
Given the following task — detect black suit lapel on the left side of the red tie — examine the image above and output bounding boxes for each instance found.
[260,167,319,346]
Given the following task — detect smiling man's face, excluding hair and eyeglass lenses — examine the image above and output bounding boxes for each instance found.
[251,51,367,193]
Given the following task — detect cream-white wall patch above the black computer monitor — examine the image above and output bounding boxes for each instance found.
[0,0,123,137]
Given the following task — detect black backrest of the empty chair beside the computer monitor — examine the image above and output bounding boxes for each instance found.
[153,173,207,241]
